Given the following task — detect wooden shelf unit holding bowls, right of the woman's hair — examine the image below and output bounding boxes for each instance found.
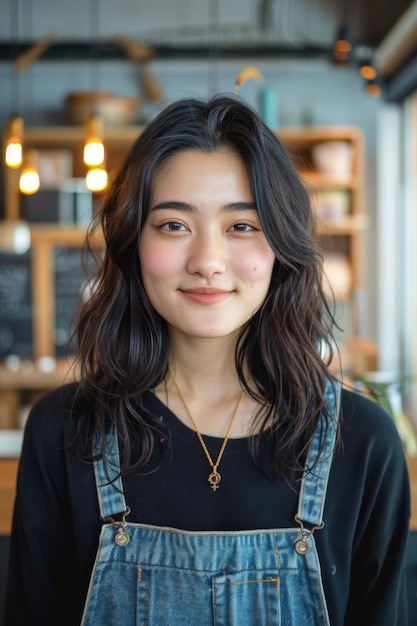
[277,126,378,373]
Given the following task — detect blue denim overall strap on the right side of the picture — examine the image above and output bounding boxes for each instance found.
[297,379,341,527]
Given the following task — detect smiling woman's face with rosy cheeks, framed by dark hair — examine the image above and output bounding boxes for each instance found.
[139,149,275,338]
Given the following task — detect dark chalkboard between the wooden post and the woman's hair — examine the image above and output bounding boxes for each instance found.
[53,247,94,357]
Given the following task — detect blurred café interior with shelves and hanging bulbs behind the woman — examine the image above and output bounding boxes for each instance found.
[0,0,417,611]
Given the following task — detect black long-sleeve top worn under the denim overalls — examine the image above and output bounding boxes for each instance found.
[5,385,410,626]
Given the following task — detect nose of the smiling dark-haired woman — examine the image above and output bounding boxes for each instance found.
[187,231,227,278]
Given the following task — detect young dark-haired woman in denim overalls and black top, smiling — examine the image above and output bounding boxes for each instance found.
[6,96,409,626]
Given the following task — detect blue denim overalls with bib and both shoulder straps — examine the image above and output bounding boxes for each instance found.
[81,381,340,626]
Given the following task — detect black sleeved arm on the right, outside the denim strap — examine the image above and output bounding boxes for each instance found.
[317,388,410,624]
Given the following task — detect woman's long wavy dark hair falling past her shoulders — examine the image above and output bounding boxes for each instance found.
[76,96,333,473]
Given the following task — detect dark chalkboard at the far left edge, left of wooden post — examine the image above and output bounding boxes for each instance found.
[0,252,33,358]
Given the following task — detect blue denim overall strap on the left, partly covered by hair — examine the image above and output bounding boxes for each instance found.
[94,430,127,518]
